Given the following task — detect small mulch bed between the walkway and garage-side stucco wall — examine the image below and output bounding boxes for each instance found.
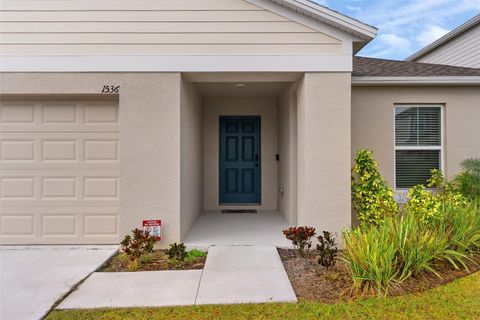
[100,250,206,272]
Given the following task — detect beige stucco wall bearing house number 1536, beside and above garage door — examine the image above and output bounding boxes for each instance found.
[0,73,181,244]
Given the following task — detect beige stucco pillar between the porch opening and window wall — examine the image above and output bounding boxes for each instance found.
[297,73,351,234]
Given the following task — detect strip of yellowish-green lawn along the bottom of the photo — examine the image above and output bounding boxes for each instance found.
[47,272,480,320]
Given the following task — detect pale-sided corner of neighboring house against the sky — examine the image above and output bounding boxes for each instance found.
[406,14,480,68]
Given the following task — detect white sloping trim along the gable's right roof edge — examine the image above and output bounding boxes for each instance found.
[260,0,378,42]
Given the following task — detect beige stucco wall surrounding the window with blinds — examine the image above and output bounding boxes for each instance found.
[352,86,480,186]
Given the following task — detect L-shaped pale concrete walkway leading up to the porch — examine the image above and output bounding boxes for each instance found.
[57,246,297,309]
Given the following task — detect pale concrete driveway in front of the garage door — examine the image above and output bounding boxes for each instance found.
[0,246,118,320]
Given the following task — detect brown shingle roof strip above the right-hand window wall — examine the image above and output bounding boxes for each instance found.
[352,56,480,77]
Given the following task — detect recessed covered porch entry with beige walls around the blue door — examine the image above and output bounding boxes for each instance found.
[181,73,301,246]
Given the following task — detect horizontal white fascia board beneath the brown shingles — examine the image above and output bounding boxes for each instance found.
[352,76,480,86]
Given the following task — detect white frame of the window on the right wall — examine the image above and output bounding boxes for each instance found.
[393,103,445,192]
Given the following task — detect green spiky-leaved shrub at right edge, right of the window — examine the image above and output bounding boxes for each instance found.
[455,158,480,199]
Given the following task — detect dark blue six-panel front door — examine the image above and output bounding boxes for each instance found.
[220,117,260,204]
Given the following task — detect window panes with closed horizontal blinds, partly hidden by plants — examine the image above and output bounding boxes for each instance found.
[395,105,442,189]
